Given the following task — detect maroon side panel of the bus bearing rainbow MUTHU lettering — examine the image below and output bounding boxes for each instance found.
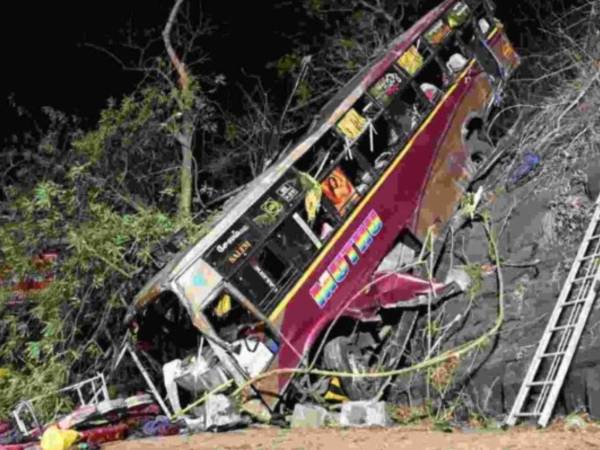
[272,63,490,387]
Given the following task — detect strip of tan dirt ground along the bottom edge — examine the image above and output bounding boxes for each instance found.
[103,426,600,450]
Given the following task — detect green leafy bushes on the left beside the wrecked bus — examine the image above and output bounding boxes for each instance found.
[0,88,211,418]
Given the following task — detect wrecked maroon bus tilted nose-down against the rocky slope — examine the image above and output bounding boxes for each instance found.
[128,0,519,420]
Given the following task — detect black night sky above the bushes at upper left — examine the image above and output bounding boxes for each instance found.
[0,0,298,136]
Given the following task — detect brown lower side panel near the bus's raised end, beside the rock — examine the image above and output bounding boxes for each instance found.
[413,66,492,241]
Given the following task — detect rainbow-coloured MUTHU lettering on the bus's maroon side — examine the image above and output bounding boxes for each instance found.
[309,210,383,308]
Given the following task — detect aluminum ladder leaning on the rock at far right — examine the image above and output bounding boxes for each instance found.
[505,192,600,427]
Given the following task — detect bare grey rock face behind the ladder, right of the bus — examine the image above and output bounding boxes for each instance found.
[390,156,600,417]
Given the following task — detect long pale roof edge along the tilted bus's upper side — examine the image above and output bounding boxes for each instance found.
[134,0,459,306]
